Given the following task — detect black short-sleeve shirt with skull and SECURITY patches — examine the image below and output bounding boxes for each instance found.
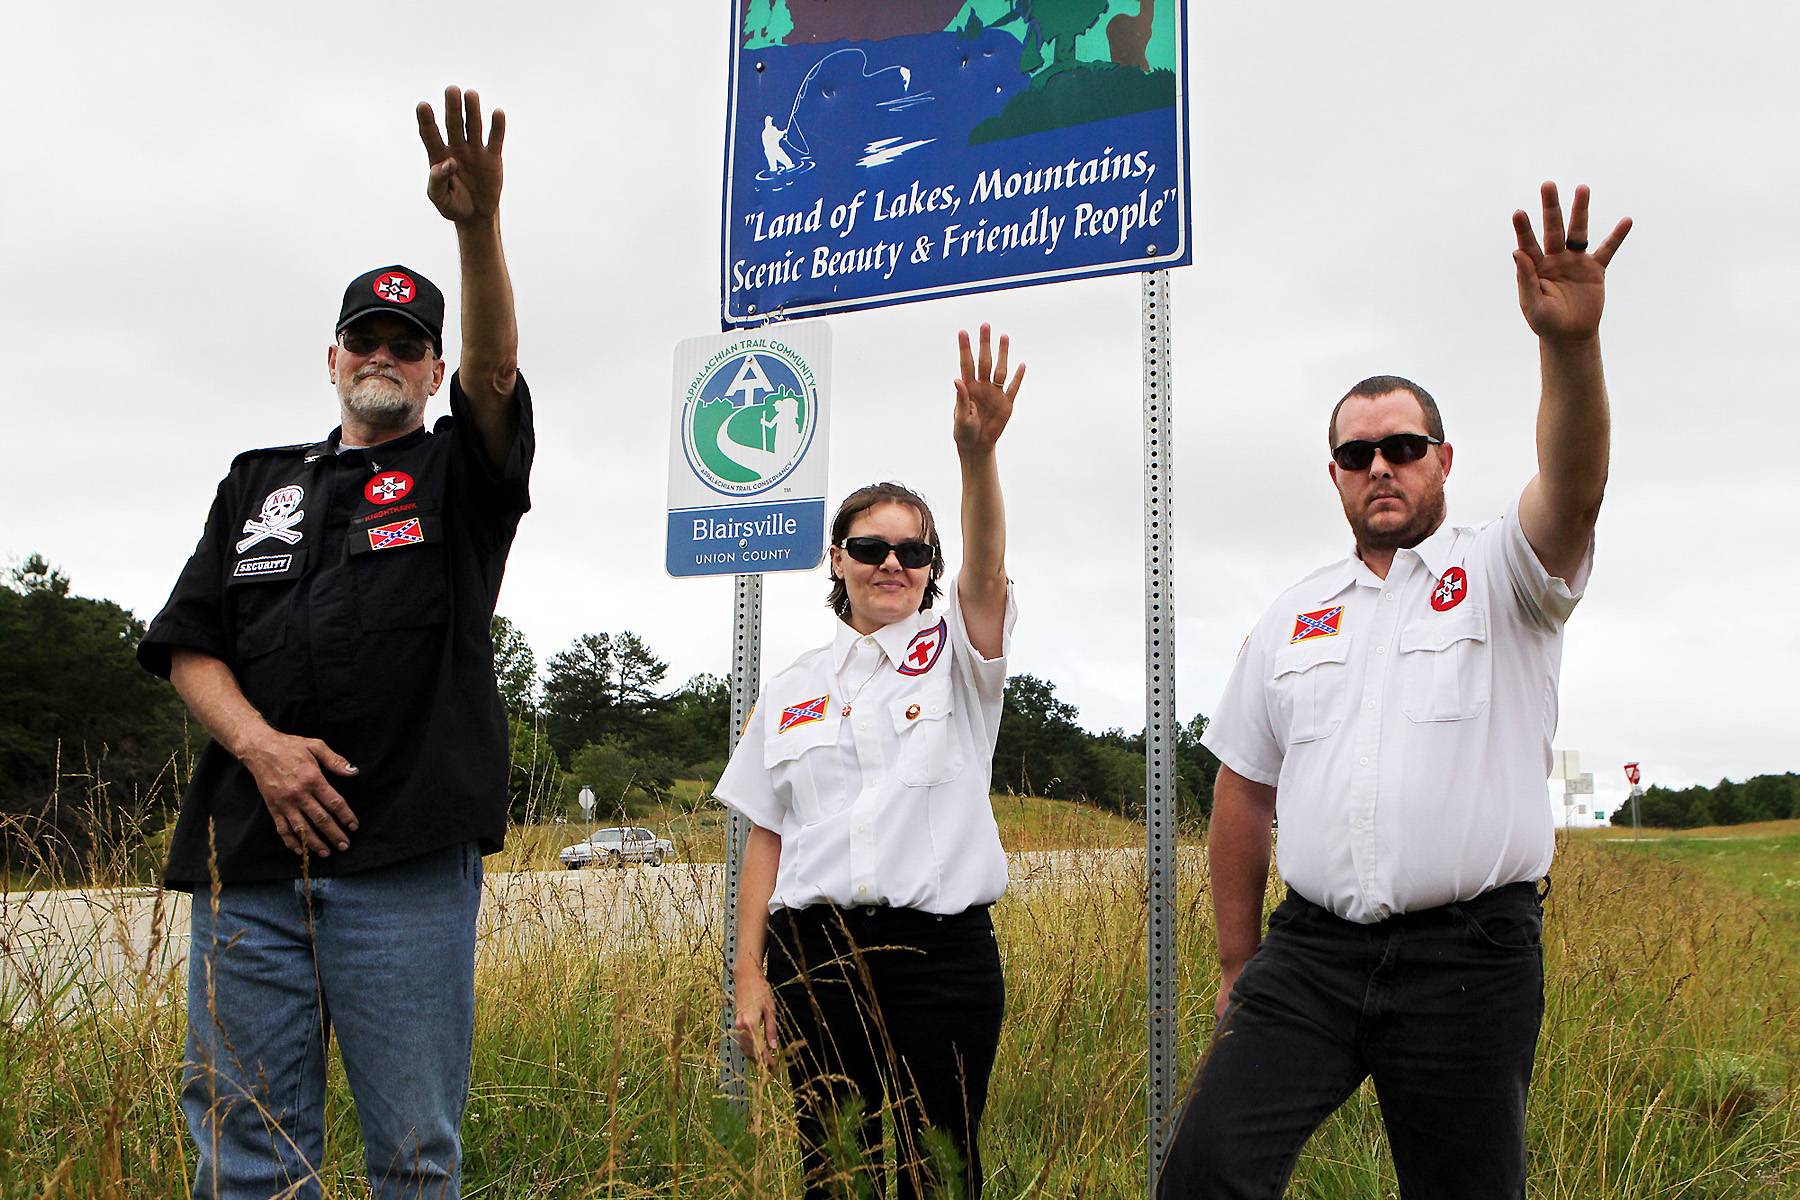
[137,376,536,889]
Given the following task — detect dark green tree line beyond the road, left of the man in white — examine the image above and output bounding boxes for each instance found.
[0,554,1217,869]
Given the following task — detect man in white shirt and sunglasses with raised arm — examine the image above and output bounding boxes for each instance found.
[1157,184,1631,1200]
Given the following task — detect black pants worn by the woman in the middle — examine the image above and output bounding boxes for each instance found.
[767,905,1006,1200]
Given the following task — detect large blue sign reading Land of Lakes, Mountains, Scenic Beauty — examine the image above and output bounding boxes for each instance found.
[722,0,1193,329]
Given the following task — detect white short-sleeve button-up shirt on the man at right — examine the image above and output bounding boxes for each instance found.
[1201,504,1593,923]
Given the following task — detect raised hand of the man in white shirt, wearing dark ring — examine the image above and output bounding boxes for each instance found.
[1512,184,1631,342]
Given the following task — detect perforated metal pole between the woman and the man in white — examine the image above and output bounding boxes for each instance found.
[1143,272,1175,1200]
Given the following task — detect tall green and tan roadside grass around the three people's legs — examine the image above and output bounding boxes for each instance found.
[0,799,1800,1200]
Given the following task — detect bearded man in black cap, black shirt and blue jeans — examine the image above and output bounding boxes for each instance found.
[139,88,535,1200]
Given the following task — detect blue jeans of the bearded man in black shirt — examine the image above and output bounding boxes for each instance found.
[182,844,481,1200]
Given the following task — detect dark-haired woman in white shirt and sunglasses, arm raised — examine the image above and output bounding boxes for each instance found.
[715,326,1024,1200]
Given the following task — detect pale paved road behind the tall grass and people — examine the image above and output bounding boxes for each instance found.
[0,849,1186,1020]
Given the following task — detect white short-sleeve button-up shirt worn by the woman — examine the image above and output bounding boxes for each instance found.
[713,581,1017,914]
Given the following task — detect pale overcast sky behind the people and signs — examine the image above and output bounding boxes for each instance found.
[0,0,1800,827]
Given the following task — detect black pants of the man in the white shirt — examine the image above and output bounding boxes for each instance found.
[1157,883,1544,1200]
